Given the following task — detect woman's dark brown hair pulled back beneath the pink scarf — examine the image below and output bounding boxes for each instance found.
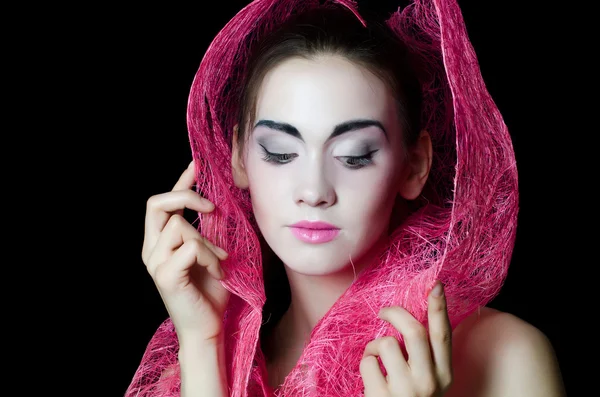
[237,8,422,351]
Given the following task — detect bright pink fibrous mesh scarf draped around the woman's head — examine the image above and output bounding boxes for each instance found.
[126,0,518,397]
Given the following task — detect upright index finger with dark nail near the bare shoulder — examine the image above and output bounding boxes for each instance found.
[427,281,452,384]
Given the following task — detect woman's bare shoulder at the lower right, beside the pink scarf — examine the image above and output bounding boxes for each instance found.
[448,307,565,397]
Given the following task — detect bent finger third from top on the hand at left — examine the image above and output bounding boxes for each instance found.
[149,215,227,267]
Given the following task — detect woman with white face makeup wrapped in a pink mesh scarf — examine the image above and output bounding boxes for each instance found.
[128,0,563,396]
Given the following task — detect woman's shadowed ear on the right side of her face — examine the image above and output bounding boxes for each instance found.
[398,130,432,200]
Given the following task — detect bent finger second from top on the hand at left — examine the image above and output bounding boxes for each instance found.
[142,190,215,257]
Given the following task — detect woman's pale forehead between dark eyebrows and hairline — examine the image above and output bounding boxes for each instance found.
[256,56,395,129]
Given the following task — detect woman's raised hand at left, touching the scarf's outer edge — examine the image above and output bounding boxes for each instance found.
[142,162,230,342]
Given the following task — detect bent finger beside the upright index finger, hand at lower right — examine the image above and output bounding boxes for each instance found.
[379,306,433,382]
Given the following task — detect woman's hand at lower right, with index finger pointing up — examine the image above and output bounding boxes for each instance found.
[360,281,452,397]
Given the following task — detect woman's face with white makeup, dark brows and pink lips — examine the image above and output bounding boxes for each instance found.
[237,56,405,275]
